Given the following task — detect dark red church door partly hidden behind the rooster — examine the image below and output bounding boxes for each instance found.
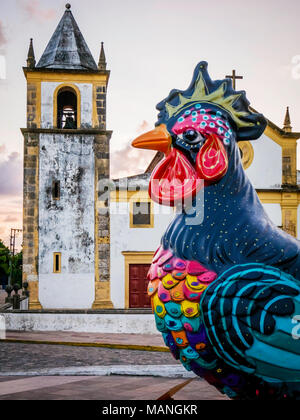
[129,264,151,308]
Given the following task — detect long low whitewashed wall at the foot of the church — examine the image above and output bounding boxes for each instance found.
[2,312,157,334]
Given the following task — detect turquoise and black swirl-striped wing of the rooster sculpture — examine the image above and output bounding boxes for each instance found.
[201,264,300,379]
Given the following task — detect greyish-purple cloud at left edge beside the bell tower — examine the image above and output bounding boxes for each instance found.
[0,152,22,196]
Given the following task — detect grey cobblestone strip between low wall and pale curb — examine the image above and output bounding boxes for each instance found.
[0,342,180,372]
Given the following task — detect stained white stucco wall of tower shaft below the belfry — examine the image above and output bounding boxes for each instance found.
[39,134,95,308]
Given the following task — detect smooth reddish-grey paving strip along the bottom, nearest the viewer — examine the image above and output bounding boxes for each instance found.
[0,376,228,402]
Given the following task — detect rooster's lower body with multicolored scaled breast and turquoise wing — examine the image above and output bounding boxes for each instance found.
[148,248,300,400]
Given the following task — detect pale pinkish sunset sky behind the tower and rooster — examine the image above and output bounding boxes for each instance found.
[0,0,300,246]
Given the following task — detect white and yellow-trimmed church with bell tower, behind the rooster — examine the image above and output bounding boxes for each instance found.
[22,4,300,310]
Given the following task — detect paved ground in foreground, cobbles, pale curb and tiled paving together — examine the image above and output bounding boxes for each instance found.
[0,333,227,401]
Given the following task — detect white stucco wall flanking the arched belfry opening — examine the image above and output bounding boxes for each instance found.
[41,82,93,128]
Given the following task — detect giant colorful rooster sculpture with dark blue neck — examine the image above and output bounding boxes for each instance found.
[133,62,300,400]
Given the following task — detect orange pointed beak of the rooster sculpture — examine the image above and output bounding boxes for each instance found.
[132,124,172,154]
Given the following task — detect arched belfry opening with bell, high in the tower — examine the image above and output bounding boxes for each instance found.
[57,87,78,130]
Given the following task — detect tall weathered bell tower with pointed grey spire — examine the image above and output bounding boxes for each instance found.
[22,4,112,309]
